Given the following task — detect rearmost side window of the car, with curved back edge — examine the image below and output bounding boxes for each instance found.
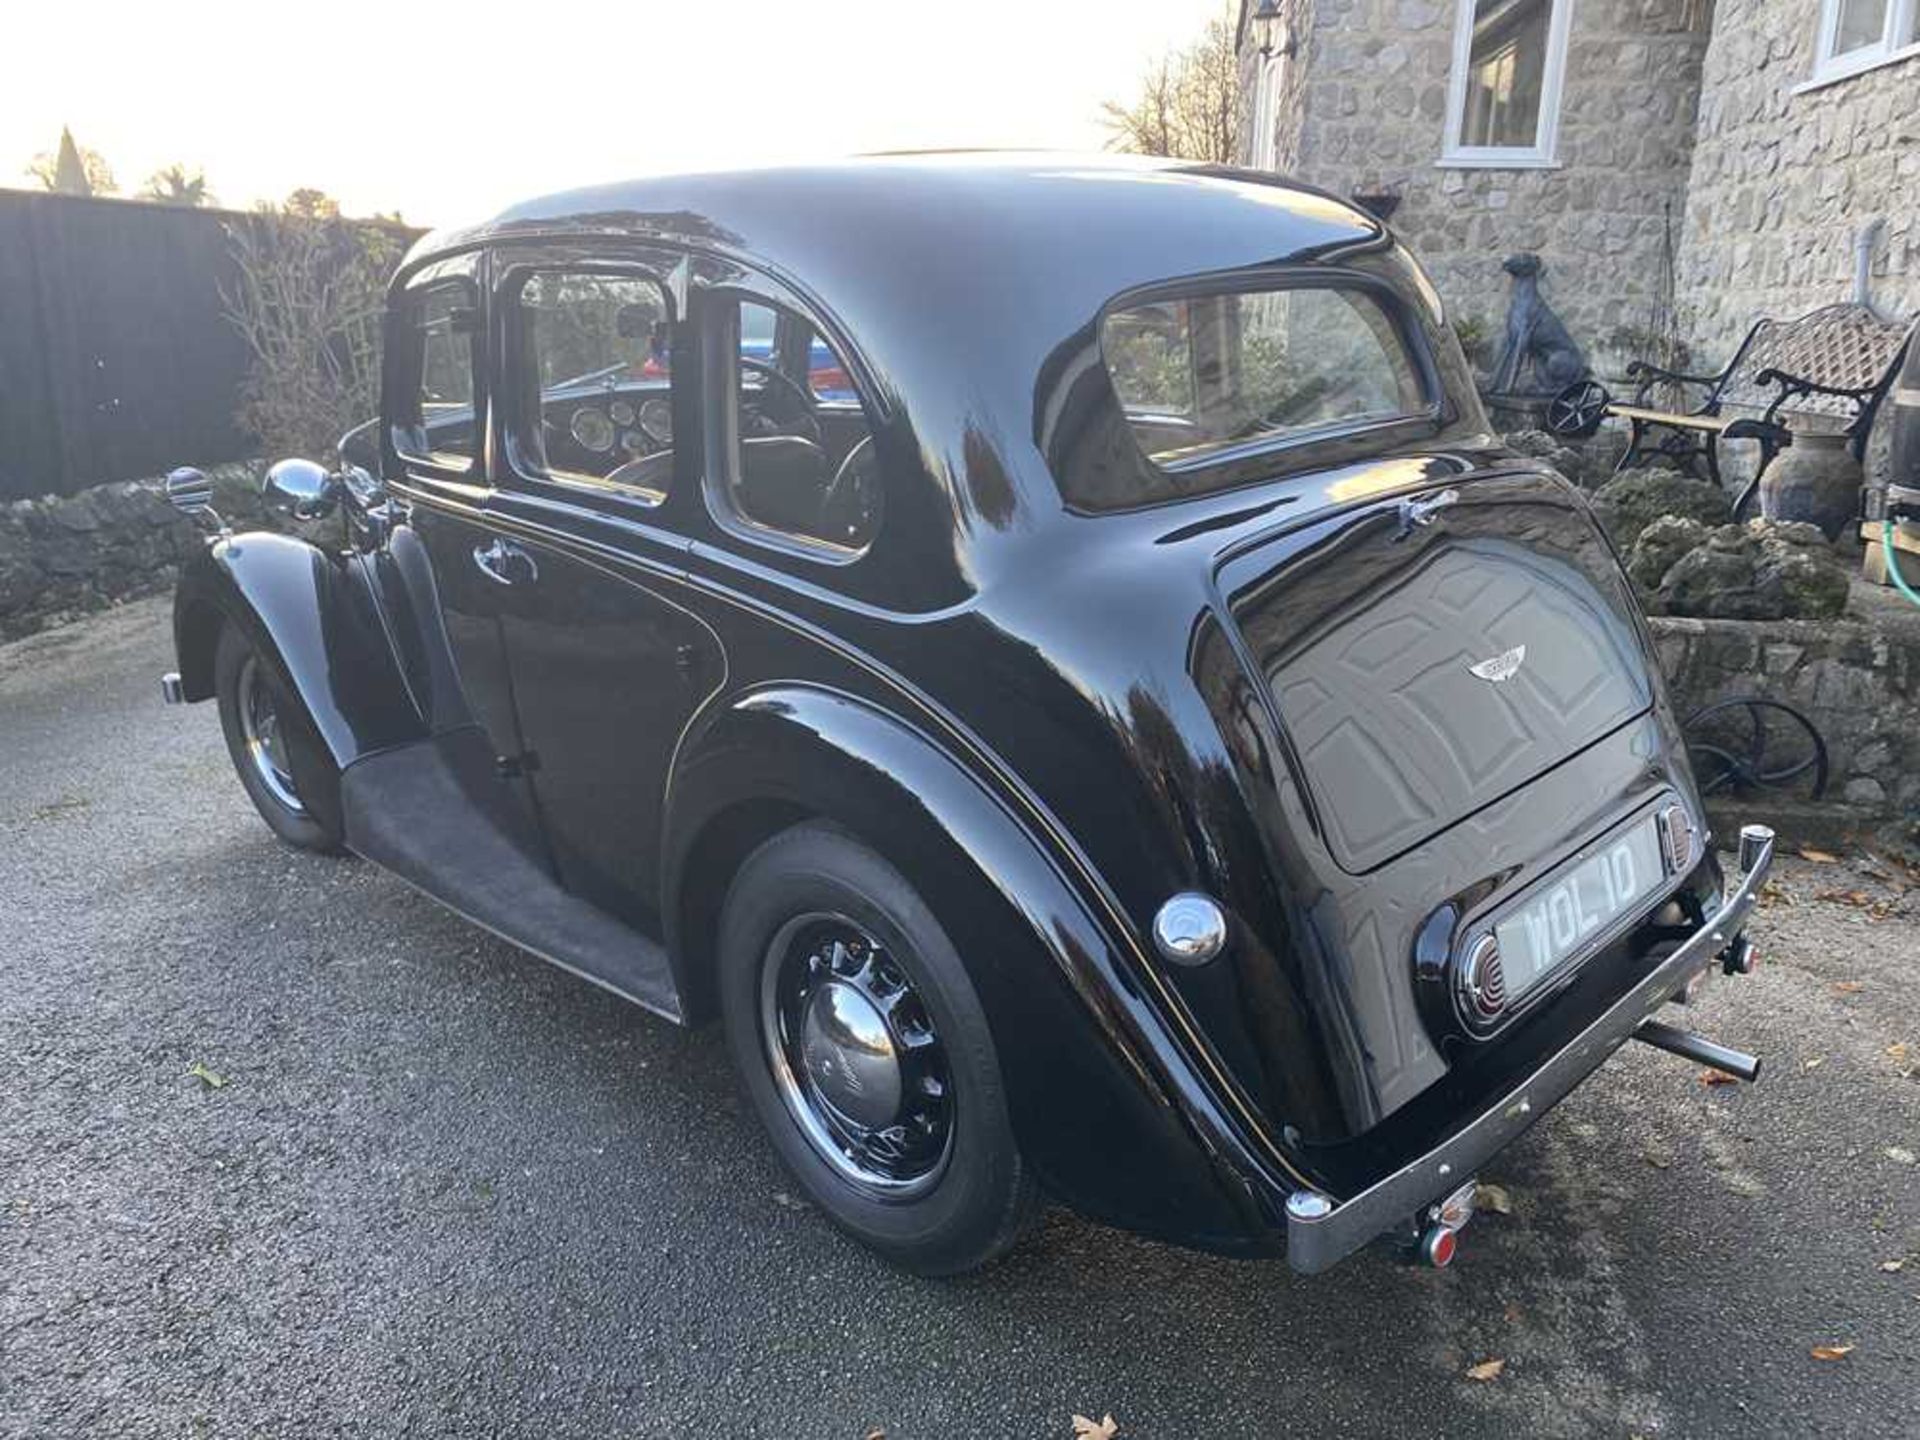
[708,298,883,559]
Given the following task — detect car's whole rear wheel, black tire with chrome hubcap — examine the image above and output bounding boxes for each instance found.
[720,824,1037,1275]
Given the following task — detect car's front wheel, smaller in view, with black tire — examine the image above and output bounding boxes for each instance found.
[213,624,342,854]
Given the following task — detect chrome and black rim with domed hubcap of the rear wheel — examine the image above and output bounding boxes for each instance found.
[760,914,954,1200]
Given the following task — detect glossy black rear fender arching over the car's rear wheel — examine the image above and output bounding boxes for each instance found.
[664,684,1305,1250]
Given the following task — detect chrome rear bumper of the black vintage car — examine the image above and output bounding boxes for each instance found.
[1286,826,1774,1275]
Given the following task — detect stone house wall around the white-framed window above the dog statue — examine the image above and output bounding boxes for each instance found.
[1246,0,1707,372]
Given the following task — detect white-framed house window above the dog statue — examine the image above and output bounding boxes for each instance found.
[1440,0,1574,169]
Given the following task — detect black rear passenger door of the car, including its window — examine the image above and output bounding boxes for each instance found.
[482,252,724,933]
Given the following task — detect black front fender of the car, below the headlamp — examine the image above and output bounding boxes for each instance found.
[173,532,426,770]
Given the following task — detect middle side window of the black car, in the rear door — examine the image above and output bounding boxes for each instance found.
[509,271,674,499]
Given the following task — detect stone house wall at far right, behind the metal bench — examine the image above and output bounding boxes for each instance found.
[1678,0,1920,365]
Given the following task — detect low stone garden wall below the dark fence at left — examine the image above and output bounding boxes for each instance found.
[0,463,261,639]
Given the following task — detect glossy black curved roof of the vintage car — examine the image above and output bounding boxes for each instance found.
[407,152,1382,307]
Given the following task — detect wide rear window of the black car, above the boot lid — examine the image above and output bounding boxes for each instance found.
[1100,286,1432,476]
